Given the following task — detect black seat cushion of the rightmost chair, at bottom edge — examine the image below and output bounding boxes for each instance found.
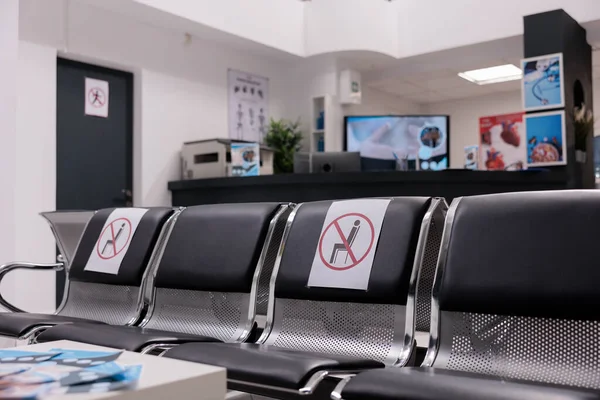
[342,368,600,400]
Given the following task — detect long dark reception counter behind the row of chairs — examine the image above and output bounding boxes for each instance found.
[169,170,568,206]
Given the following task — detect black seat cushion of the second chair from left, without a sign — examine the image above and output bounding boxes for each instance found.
[37,323,219,351]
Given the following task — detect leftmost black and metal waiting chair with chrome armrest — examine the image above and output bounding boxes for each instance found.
[0,208,174,341]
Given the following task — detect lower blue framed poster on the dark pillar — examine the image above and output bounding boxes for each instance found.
[525,111,567,167]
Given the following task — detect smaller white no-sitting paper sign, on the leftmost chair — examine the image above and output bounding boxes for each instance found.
[84,208,148,275]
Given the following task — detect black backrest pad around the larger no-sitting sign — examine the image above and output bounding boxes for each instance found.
[275,197,431,305]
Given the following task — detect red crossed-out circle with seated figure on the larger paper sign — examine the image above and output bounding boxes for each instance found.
[319,213,375,271]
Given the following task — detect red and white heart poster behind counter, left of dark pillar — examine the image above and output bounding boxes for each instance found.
[479,113,527,171]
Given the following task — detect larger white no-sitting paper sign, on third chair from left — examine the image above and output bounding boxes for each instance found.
[308,199,390,290]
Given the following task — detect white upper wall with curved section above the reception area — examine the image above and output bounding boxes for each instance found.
[127,0,600,58]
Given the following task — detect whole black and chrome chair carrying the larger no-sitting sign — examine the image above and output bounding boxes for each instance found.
[164,197,446,396]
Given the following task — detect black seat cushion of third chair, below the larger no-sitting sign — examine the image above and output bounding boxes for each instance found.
[165,343,384,390]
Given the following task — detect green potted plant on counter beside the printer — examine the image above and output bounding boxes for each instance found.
[265,118,302,174]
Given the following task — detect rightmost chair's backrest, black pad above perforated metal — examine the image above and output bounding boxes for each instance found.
[424,190,600,389]
